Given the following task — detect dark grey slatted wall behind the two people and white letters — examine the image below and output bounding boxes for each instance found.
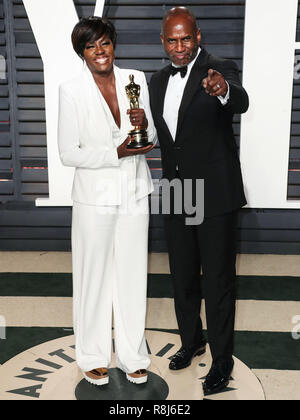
[0,0,300,254]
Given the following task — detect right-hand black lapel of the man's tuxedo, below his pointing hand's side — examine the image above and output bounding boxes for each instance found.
[175,48,209,141]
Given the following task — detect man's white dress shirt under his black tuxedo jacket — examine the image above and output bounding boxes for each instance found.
[163,48,230,141]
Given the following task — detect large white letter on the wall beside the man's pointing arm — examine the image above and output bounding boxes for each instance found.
[240,0,300,208]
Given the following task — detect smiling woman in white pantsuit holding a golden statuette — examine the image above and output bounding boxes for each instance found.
[58,17,156,385]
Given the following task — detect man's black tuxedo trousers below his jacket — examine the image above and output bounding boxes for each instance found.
[165,212,237,361]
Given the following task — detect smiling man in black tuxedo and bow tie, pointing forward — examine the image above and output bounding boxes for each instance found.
[150,7,249,395]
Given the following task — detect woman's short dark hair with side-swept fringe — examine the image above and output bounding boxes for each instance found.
[72,16,117,58]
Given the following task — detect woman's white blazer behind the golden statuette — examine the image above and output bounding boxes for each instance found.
[58,65,157,206]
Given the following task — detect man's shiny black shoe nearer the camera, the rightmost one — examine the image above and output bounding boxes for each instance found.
[203,359,234,395]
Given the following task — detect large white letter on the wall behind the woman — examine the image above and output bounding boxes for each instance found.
[23,0,104,206]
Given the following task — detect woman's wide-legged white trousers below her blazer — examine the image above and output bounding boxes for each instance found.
[72,197,150,373]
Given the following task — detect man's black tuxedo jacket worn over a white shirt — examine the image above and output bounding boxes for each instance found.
[149,49,249,217]
